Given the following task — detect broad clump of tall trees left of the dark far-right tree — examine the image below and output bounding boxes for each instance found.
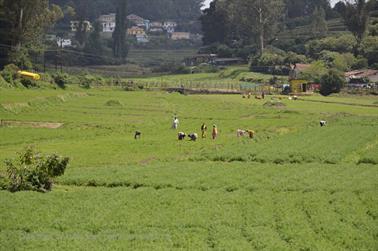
[201,0,330,51]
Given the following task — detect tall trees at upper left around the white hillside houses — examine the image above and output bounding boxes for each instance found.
[0,0,133,69]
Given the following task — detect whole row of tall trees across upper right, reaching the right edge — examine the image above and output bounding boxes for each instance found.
[201,0,377,54]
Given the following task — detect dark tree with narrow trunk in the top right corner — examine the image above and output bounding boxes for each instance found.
[343,0,369,55]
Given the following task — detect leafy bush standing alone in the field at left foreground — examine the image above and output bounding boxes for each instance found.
[1,147,69,192]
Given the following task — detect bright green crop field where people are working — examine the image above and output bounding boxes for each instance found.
[0,87,378,251]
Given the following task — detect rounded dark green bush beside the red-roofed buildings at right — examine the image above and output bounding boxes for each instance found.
[320,70,345,96]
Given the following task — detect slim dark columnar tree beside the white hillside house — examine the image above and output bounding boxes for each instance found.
[113,0,128,59]
